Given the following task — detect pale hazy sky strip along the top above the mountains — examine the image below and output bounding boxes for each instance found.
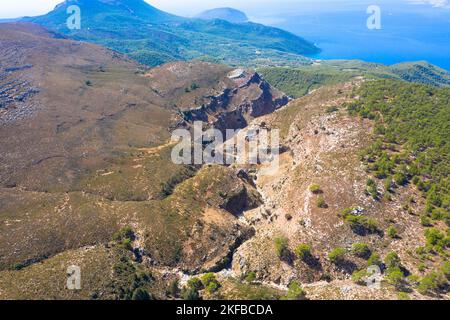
[0,0,450,18]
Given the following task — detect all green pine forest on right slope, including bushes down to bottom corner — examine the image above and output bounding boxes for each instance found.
[345,80,450,295]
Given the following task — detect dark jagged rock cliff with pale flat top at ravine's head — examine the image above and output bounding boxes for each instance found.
[147,62,289,131]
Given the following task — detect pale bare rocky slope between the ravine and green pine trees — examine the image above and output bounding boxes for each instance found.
[231,82,432,299]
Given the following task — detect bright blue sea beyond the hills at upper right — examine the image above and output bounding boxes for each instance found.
[250,0,450,70]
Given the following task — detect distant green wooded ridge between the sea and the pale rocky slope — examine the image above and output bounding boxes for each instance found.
[258,60,450,97]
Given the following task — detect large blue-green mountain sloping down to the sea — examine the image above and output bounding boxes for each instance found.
[24,0,319,66]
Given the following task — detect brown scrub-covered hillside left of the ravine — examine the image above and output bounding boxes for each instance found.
[0,24,283,299]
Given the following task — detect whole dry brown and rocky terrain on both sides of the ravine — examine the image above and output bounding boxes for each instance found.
[0,24,445,299]
